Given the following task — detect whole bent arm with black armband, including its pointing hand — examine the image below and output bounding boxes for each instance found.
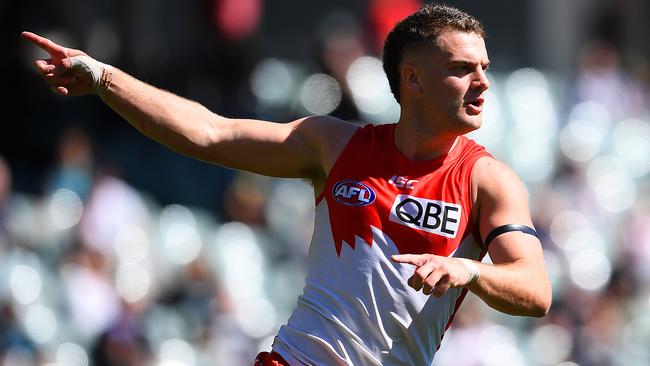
[392,158,551,317]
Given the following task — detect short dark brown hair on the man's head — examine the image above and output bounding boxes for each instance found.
[383,3,485,103]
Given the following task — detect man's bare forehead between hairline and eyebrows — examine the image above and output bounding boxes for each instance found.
[436,31,488,63]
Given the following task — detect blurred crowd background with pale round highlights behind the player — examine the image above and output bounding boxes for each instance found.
[0,0,650,366]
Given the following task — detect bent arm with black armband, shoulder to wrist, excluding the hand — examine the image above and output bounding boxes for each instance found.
[467,158,551,316]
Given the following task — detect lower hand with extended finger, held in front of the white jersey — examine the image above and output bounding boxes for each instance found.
[391,254,472,297]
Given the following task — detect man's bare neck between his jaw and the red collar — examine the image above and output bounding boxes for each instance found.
[393,118,458,160]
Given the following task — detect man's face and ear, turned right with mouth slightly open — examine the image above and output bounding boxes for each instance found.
[403,31,490,134]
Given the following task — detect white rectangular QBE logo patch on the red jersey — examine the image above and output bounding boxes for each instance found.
[390,194,461,238]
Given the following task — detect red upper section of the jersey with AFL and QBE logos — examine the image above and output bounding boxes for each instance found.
[323,125,490,256]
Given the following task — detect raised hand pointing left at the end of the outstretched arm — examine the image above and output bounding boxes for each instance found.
[21,32,93,95]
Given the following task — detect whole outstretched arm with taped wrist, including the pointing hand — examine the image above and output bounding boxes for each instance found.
[23,32,356,193]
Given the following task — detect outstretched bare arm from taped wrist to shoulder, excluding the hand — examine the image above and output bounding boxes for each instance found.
[100,69,354,180]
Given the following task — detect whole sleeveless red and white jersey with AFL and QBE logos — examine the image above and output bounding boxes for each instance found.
[273,125,490,366]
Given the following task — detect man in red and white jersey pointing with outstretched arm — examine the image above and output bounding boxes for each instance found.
[23,5,551,365]
